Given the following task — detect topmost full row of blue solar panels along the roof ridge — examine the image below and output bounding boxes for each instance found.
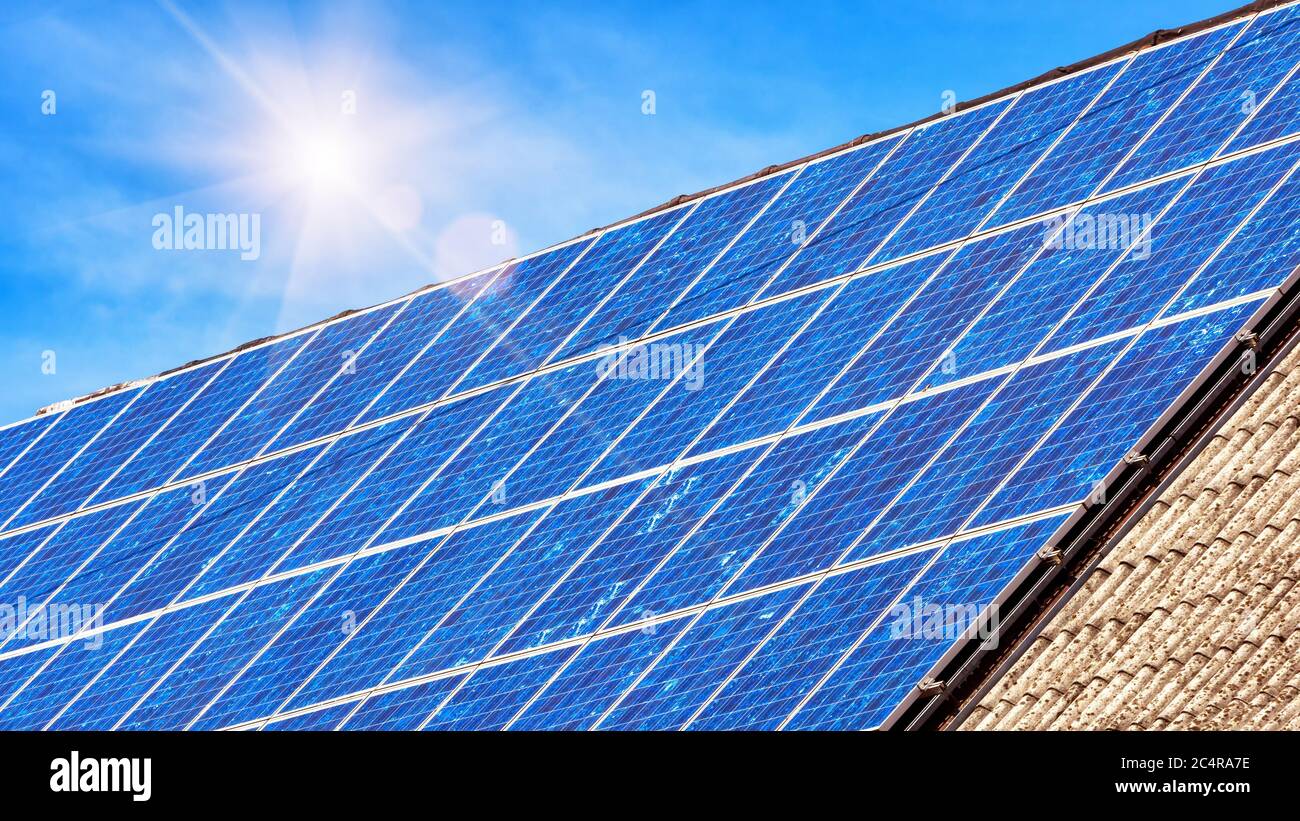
[0,8,1300,530]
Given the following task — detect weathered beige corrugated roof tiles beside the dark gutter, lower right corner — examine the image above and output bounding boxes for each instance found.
[962,348,1300,730]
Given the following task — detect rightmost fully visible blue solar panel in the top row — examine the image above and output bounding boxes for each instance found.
[992,22,1242,225]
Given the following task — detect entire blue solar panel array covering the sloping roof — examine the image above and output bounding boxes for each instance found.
[0,6,1300,729]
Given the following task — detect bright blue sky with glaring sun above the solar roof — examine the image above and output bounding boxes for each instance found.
[0,0,1227,423]
